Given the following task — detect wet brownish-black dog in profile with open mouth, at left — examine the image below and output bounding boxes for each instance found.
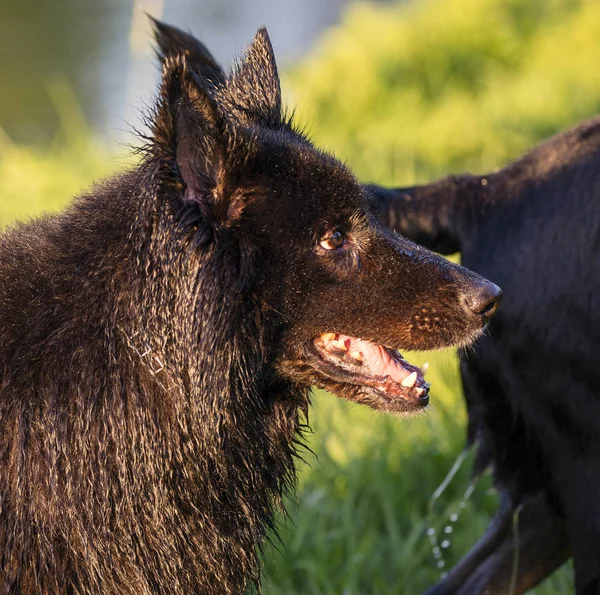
[0,21,499,595]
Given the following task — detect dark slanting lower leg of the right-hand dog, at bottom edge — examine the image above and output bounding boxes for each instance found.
[424,495,569,595]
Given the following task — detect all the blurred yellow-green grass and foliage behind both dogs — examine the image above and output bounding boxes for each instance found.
[0,0,600,595]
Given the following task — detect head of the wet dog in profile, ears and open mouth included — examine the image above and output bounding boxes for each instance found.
[148,23,500,411]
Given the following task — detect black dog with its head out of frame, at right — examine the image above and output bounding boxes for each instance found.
[372,120,600,595]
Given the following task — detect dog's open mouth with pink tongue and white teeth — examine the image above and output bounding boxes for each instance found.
[311,333,430,410]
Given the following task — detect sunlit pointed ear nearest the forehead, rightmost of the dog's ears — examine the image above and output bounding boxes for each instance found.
[227,27,282,127]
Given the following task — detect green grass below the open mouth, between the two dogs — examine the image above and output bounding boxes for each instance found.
[265,370,573,595]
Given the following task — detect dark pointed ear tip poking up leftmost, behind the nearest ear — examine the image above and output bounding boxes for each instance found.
[150,17,225,84]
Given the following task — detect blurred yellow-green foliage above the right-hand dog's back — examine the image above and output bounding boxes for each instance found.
[286,0,600,184]
